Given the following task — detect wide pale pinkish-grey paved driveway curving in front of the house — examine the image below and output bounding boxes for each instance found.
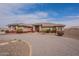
[0,33,79,56]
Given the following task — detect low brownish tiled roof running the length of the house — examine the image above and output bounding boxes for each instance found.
[8,23,65,27]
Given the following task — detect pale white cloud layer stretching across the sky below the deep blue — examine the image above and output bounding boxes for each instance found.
[0,4,79,27]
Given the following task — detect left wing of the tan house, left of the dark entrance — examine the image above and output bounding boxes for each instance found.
[8,23,32,33]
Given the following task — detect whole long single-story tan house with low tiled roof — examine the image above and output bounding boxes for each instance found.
[8,23,65,32]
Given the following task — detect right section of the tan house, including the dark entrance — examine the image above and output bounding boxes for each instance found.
[33,23,65,32]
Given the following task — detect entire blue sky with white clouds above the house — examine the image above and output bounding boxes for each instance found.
[0,3,79,27]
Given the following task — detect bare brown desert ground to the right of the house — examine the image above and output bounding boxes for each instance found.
[64,28,79,40]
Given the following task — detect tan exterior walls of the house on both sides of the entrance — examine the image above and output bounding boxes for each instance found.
[9,25,64,33]
